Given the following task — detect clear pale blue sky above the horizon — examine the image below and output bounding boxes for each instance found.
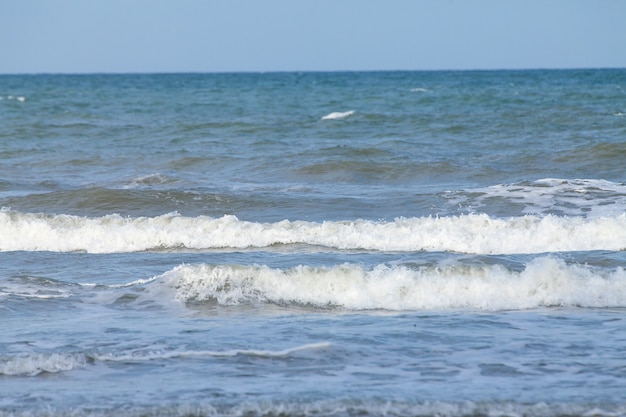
[0,0,626,74]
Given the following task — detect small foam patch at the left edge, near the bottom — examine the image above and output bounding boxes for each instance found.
[0,353,87,376]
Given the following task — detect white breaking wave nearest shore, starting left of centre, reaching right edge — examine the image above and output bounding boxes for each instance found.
[158,256,626,311]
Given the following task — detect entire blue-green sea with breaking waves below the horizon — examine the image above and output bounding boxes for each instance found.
[0,69,626,417]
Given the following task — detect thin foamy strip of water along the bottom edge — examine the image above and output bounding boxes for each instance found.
[0,398,626,417]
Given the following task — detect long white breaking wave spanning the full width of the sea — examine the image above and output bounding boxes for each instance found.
[0,209,626,254]
